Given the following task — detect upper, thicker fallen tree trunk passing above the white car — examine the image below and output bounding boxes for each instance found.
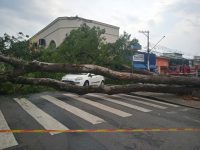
[0,55,200,87]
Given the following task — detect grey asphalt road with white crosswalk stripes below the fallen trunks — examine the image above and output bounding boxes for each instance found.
[0,92,200,150]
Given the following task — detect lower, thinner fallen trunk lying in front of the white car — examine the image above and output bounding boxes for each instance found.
[5,77,196,94]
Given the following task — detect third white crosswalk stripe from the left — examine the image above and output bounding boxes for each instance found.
[41,95,105,124]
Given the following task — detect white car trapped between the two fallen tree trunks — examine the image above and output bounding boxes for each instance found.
[62,73,105,86]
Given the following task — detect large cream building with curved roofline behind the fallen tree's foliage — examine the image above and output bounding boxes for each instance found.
[30,17,119,47]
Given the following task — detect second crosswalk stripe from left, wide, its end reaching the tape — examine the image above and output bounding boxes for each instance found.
[14,98,69,135]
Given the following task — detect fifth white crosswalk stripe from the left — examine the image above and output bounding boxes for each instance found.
[87,94,152,112]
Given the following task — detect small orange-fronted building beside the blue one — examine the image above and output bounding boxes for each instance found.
[156,56,169,74]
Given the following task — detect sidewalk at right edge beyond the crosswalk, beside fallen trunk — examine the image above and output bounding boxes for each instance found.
[133,92,200,109]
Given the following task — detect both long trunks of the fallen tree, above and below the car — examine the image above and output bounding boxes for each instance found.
[0,55,200,94]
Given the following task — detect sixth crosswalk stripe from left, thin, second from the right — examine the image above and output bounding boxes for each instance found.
[112,94,167,109]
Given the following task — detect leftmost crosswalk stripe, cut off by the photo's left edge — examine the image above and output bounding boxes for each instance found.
[0,110,18,149]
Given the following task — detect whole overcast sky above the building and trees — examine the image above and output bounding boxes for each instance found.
[0,0,200,56]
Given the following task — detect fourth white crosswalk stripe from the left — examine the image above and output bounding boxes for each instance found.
[64,93,132,117]
